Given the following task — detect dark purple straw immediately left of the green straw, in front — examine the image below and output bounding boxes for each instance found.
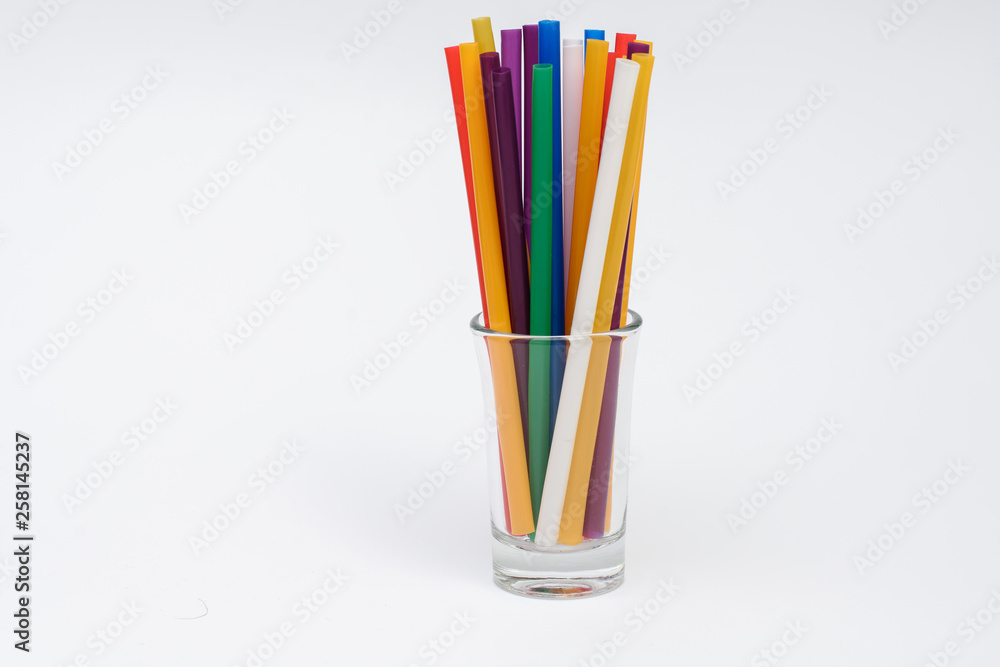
[490,66,530,464]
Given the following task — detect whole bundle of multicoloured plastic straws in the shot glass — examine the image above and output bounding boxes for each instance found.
[445,18,653,546]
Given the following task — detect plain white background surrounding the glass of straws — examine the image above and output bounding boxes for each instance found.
[0,0,1000,667]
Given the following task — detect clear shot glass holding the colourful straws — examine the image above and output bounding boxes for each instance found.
[470,310,642,598]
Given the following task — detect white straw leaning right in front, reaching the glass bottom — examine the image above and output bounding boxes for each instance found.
[535,58,639,546]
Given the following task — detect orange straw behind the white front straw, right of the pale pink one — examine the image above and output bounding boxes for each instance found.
[566,40,608,330]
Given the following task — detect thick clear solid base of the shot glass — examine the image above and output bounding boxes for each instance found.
[493,526,625,599]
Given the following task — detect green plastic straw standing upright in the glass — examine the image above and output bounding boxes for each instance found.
[528,64,555,516]
